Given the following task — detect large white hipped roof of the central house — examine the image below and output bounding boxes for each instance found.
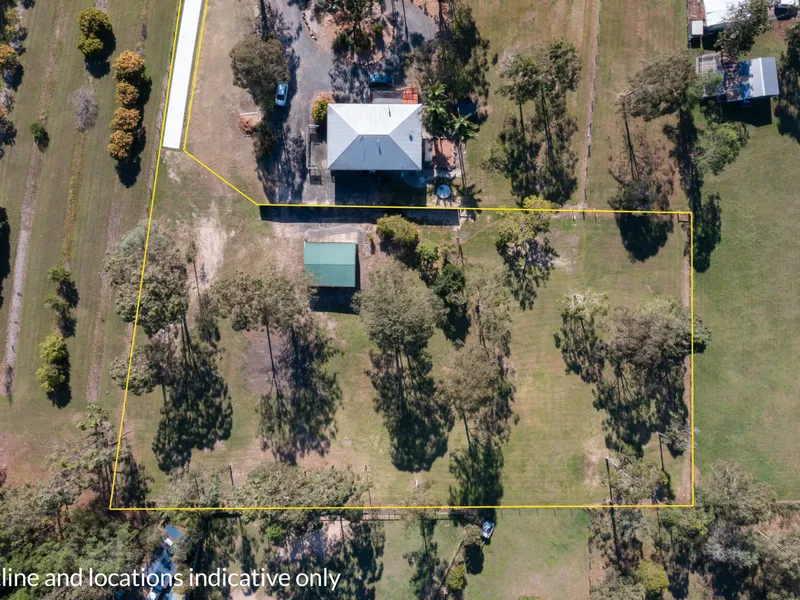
[328,104,422,171]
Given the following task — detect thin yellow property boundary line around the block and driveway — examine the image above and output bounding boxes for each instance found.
[108,0,695,512]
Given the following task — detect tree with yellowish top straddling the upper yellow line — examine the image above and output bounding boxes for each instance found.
[495,197,558,309]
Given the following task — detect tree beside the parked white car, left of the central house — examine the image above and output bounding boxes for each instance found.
[230,35,289,114]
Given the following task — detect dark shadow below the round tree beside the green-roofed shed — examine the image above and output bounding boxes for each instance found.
[368,350,453,471]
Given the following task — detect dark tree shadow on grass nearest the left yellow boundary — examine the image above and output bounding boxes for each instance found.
[152,343,233,472]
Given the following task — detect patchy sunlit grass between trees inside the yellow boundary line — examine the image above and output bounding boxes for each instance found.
[126,153,685,505]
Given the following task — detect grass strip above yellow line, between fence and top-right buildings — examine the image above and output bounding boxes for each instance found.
[588,0,686,210]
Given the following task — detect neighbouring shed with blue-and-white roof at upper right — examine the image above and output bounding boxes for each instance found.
[695,53,780,102]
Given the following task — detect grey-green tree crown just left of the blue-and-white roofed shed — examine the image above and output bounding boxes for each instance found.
[619,50,697,122]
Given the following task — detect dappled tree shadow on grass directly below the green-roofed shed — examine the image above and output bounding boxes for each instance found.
[259,319,342,464]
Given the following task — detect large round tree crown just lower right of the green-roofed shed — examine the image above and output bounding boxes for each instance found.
[357,265,440,362]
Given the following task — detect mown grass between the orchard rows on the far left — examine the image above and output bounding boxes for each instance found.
[0,0,176,480]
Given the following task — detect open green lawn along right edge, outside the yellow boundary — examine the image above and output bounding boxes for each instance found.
[695,32,800,500]
